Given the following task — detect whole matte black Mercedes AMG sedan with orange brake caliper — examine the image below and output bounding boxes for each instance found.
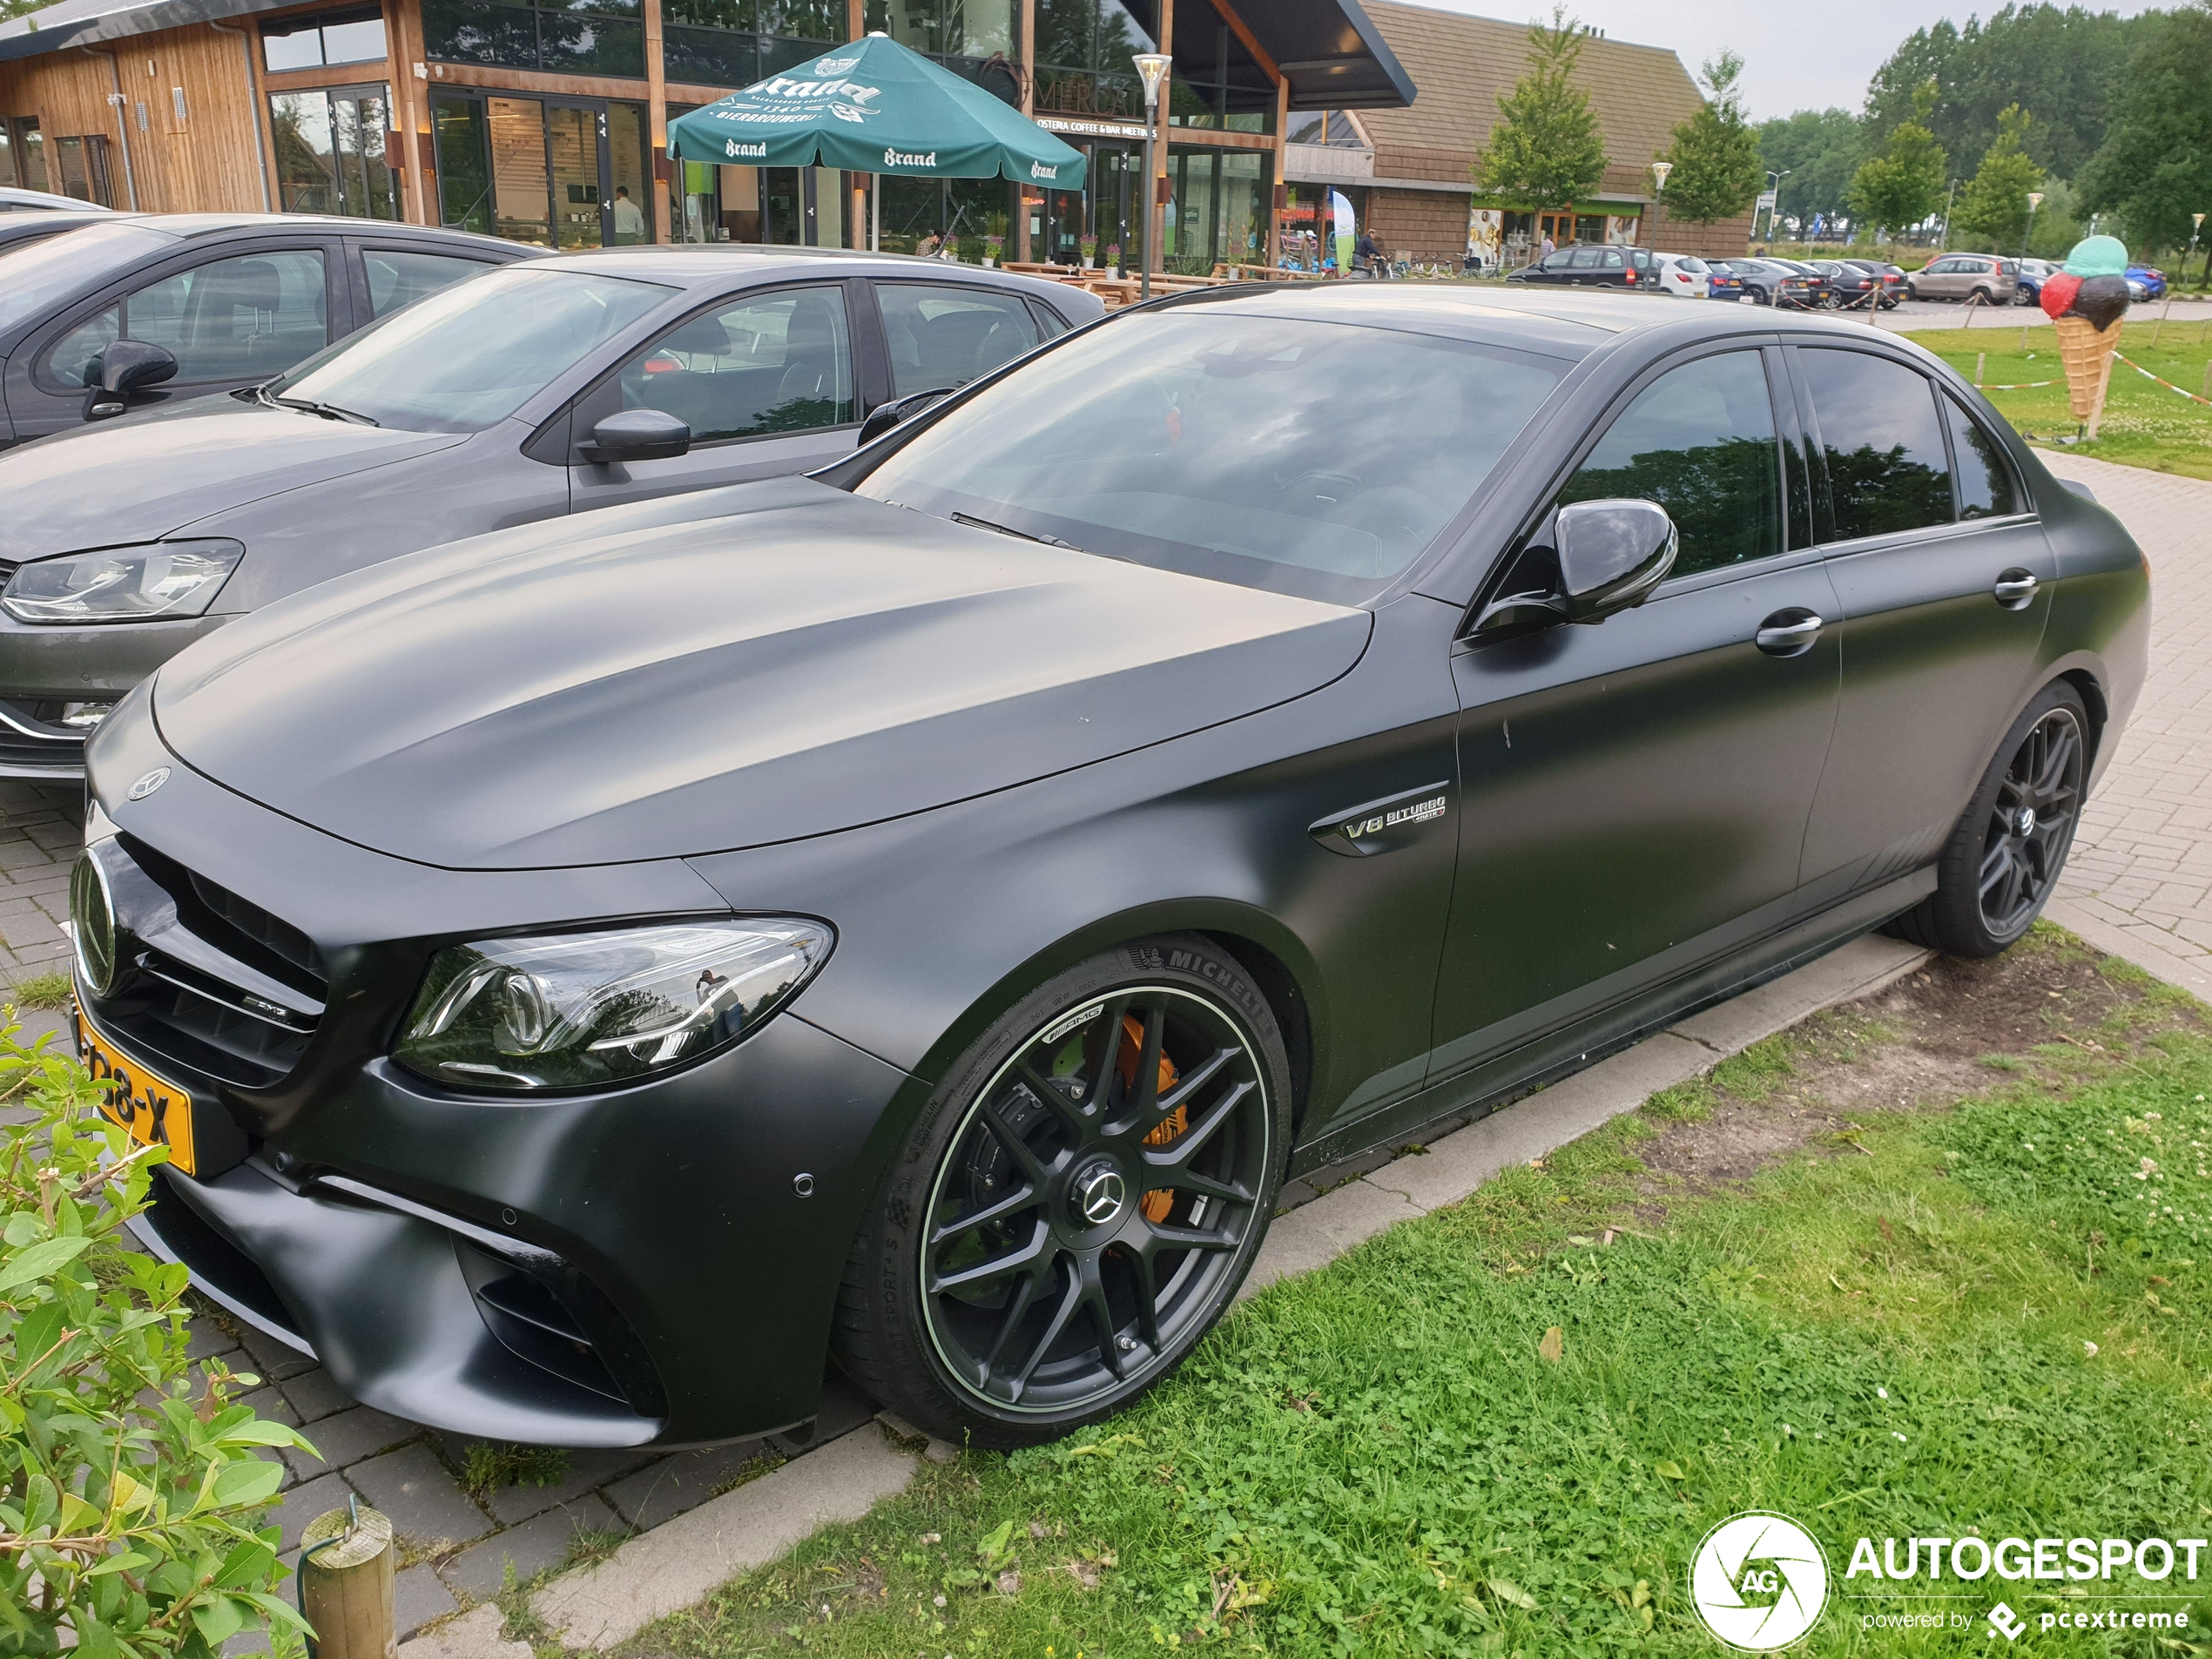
[73,283,2148,1447]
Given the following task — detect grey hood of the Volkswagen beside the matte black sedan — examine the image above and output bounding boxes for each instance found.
[0,396,462,564]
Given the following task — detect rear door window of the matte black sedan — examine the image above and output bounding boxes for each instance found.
[1798,347,1951,542]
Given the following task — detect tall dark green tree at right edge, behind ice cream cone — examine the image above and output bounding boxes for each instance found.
[2081,3,2212,253]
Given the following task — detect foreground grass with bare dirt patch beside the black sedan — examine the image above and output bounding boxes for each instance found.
[592,929,2212,1659]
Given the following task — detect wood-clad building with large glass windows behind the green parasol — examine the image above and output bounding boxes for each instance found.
[0,0,1413,270]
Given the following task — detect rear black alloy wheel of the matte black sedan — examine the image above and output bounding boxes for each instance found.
[1889,681,2090,955]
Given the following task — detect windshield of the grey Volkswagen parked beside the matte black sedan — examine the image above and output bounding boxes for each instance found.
[270,266,675,431]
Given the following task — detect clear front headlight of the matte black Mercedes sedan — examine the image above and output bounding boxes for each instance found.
[394,916,834,1090]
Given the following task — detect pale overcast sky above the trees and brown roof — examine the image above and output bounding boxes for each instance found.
[1412,0,2150,122]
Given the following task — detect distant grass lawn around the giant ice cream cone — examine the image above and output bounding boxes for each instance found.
[1909,320,2212,478]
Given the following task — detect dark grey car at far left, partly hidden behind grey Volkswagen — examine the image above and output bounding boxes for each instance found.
[0,212,531,449]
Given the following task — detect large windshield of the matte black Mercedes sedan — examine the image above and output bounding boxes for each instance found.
[856,306,1573,604]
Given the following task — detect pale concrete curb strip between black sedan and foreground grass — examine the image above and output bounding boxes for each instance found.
[401,935,1931,1659]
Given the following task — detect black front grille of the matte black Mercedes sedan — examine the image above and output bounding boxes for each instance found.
[95,836,327,1089]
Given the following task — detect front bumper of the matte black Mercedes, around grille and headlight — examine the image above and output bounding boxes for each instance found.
[86,697,922,1447]
